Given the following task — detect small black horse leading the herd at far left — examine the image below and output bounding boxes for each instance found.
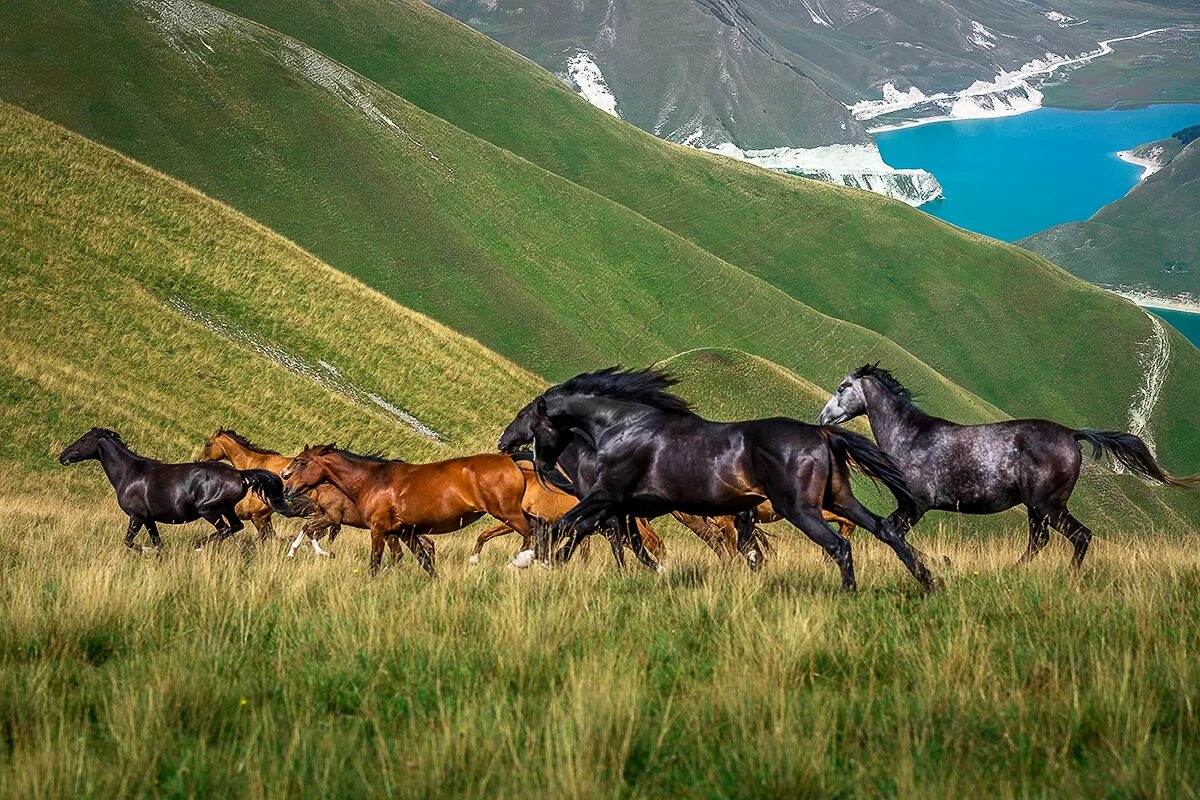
[59,428,311,553]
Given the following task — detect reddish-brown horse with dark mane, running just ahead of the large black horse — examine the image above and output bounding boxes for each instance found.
[280,445,533,577]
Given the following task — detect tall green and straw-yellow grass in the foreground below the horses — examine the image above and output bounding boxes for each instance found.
[0,497,1200,798]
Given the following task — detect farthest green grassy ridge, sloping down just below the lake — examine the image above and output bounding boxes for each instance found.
[180,0,1200,469]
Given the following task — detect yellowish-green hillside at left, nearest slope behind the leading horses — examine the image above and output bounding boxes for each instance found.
[0,103,539,494]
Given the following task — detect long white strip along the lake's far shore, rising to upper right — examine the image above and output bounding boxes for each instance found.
[847,28,1175,133]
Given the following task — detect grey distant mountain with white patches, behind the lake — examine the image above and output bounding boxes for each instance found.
[430,0,1200,205]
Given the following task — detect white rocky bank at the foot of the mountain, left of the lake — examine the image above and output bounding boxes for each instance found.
[703,143,942,206]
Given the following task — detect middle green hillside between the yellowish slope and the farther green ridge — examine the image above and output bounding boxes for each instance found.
[0,4,1003,429]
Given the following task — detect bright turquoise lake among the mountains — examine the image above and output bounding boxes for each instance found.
[875,104,1200,347]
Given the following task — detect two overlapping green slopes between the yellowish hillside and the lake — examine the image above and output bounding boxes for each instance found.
[0,0,1200,482]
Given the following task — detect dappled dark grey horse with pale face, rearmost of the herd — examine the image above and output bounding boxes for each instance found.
[821,365,1200,567]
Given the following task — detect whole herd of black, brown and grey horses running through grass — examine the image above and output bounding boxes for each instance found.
[59,365,1200,591]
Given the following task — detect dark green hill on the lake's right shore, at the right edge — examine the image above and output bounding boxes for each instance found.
[1021,142,1200,301]
